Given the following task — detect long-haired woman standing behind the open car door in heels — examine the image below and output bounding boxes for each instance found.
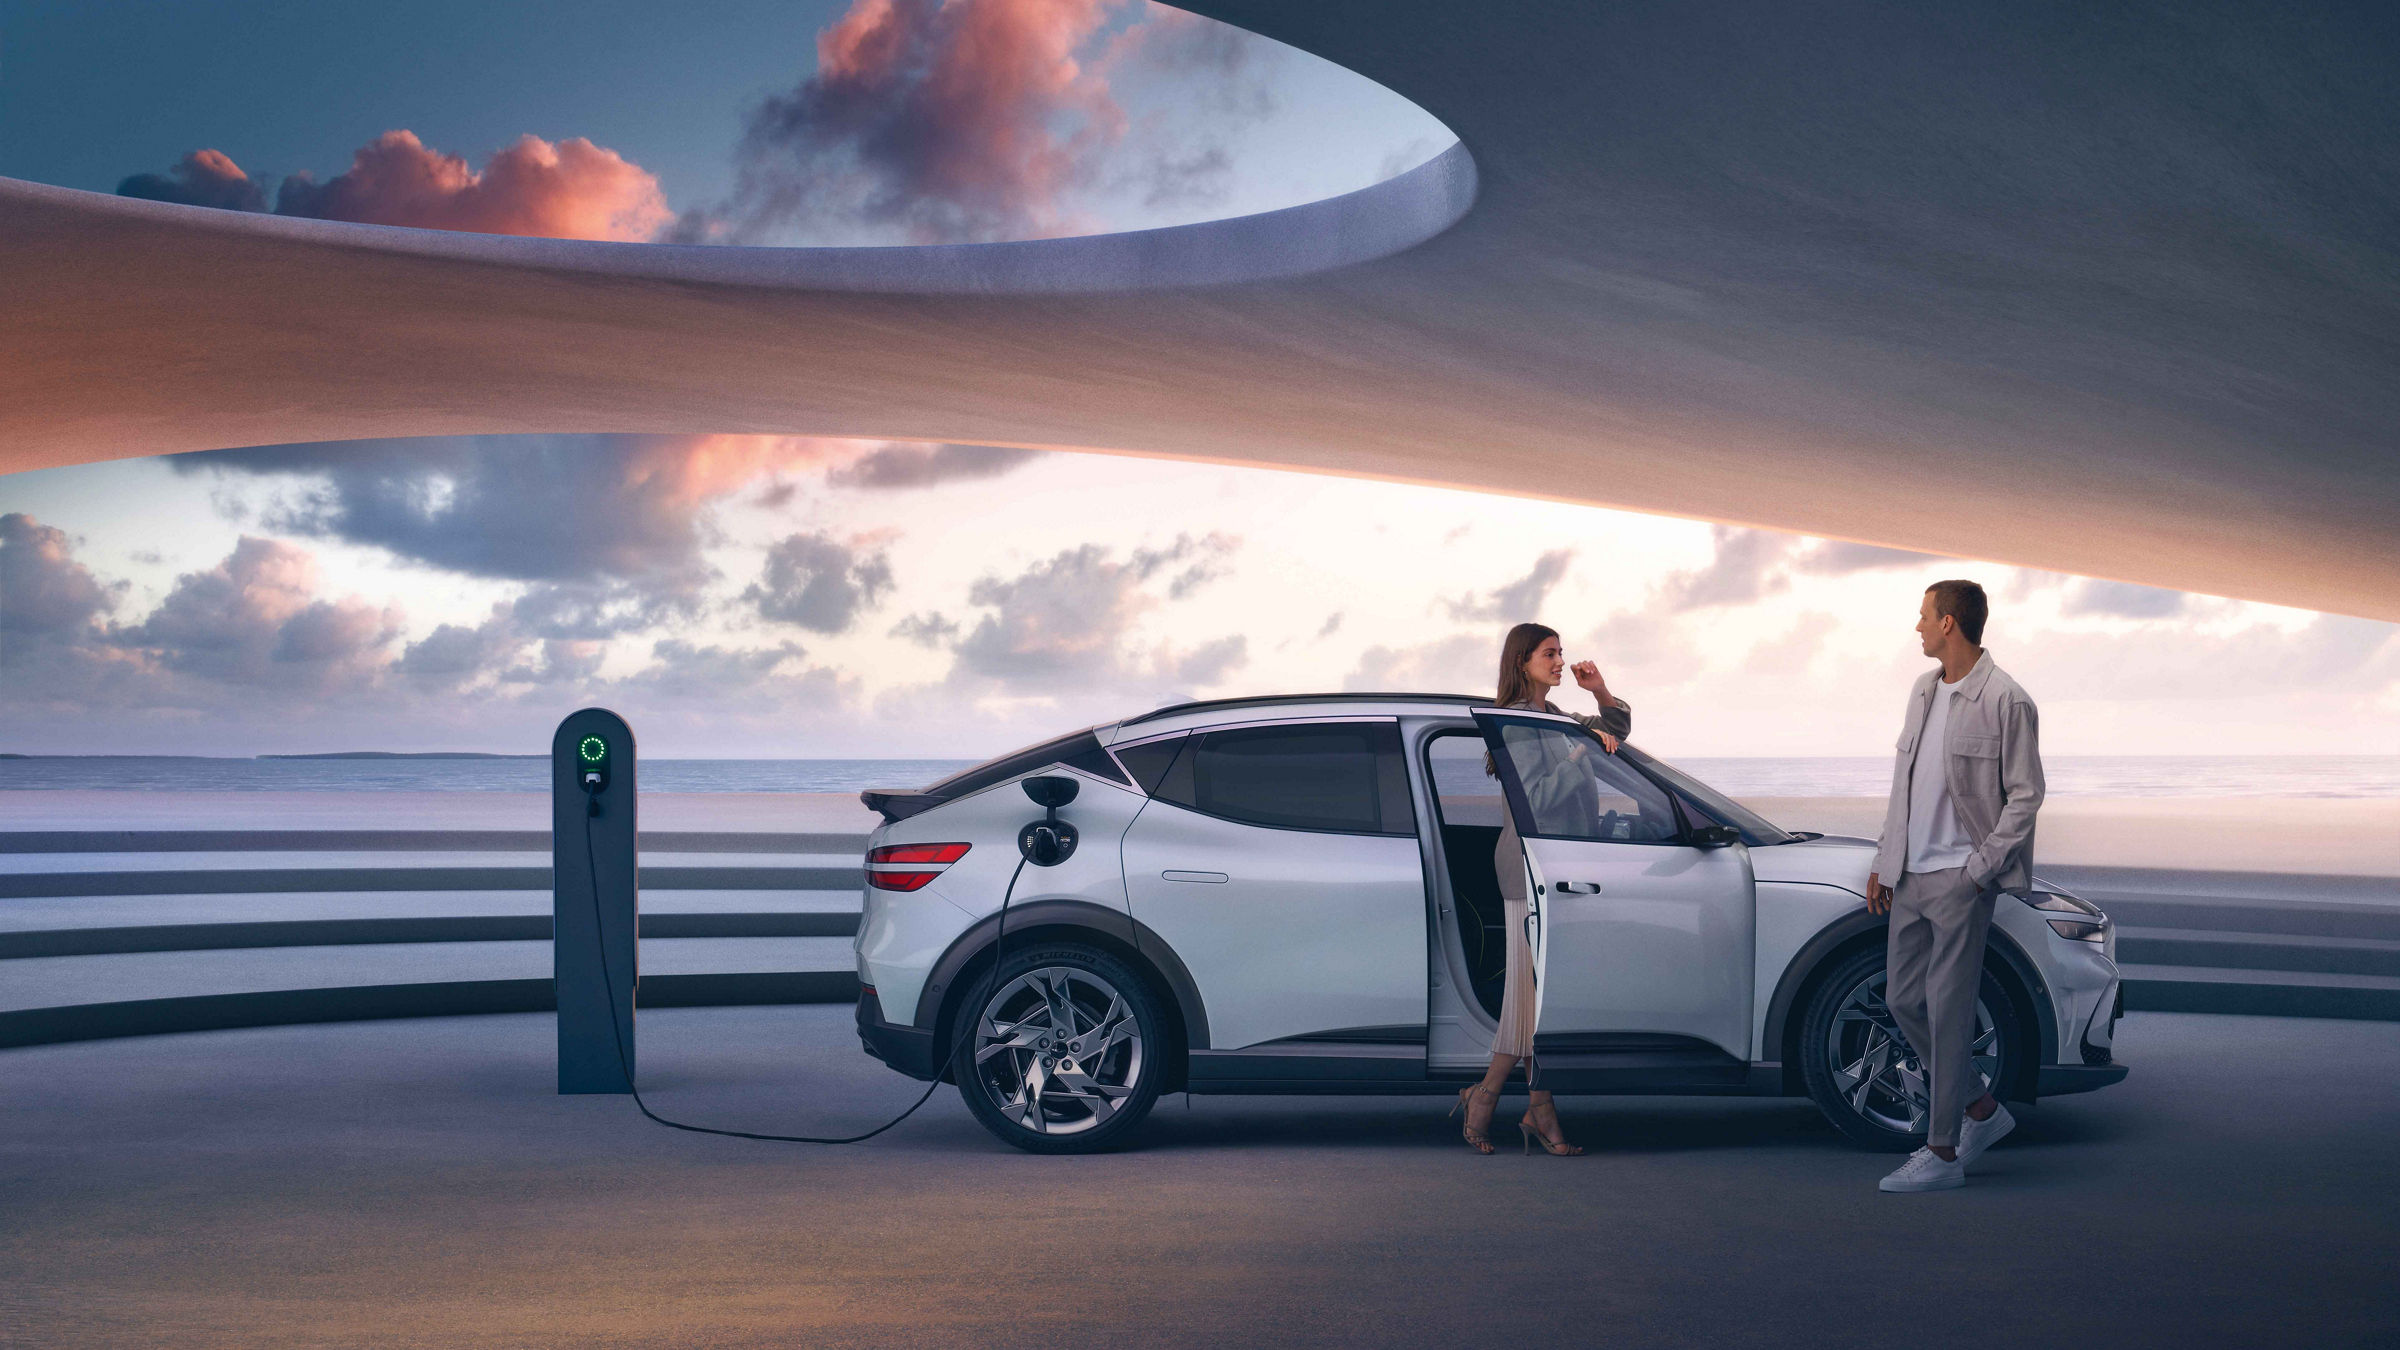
[1459,625,1634,1158]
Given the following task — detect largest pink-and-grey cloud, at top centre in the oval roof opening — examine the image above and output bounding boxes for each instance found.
[696,0,1282,245]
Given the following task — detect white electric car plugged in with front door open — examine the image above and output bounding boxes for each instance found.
[857,694,2126,1153]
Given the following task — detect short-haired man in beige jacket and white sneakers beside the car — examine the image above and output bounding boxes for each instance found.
[1867,581,2042,1191]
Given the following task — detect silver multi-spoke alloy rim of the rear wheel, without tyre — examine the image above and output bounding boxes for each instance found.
[974,966,1142,1134]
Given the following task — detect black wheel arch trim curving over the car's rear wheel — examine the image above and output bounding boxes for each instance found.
[914,901,1207,1093]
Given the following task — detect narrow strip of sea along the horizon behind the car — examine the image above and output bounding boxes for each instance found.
[0,754,2400,792]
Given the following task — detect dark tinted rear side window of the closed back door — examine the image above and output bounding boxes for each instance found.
[1135,723,1416,836]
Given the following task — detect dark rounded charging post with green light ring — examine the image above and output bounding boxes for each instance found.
[550,709,641,1093]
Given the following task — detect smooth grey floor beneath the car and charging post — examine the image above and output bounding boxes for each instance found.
[0,1006,2400,1348]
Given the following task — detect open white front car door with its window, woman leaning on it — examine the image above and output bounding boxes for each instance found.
[1474,711,1757,1093]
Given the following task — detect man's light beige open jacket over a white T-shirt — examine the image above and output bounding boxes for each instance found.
[1874,651,2042,891]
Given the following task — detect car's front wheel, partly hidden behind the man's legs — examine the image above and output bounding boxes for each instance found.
[1800,946,2033,1153]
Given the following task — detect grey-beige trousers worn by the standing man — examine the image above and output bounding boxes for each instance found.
[1884,867,1999,1148]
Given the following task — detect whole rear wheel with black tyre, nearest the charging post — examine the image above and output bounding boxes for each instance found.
[950,942,1171,1153]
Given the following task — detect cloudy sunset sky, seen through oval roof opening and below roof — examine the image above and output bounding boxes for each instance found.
[0,0,2400,757]
